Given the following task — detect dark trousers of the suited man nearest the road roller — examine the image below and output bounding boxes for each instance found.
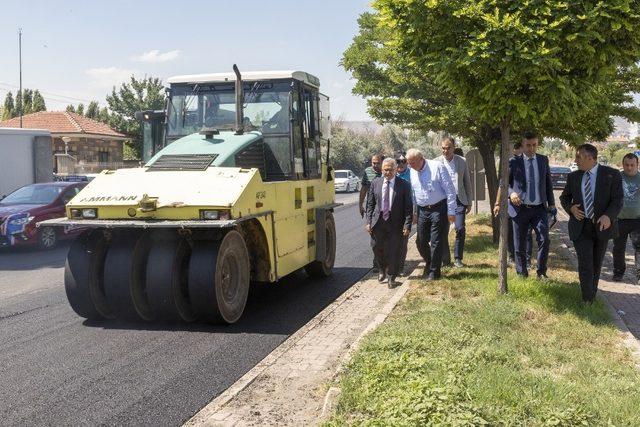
[371,218,403,276]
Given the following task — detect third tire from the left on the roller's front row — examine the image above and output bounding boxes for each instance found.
[147,236,195,322]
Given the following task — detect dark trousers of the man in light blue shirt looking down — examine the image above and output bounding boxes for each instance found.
[416,203,449,278]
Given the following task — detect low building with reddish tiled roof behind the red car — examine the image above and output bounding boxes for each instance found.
[0,111,128,170]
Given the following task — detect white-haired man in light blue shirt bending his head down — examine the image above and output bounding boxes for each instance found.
[407,148,458,281]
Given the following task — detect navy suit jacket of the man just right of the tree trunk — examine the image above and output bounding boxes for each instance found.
[507,154,556,218]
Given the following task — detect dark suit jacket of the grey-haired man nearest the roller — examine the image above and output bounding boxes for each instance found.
[365,177,413,230]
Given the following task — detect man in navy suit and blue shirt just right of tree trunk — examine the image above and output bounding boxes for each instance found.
[509,132,555,280]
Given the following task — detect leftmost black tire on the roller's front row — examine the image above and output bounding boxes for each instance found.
[64,230,113,320]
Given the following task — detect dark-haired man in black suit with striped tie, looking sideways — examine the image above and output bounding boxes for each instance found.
[560,144,624,304]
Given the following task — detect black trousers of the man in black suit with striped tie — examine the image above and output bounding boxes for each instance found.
[573,220,608,301]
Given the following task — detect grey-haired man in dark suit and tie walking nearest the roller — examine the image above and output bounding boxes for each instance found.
[365,158,413,289]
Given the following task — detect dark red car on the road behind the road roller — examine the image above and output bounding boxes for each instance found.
[0,182,87,249]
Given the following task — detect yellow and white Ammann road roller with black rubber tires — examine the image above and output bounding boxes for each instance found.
[42,66,336,323]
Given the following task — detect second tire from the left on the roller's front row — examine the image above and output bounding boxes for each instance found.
[104,231,153,321]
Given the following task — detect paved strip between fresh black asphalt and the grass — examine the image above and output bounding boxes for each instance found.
[185,237,418,426]
